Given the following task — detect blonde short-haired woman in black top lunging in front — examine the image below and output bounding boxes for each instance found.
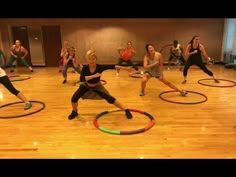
[68,50,133,120]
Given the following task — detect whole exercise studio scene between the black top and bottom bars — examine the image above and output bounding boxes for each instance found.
[0,18,236,159]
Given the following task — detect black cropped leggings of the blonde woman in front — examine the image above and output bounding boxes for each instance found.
[71,85,116,104]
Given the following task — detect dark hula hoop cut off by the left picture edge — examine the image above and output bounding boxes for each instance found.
[0,101,46,119]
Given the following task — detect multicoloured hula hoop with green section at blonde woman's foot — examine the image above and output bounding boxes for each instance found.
[93,109,155,135]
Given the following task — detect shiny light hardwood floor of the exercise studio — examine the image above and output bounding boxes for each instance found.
[0,65,236,159]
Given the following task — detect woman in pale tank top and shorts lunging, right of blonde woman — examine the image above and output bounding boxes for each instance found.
[139,44,187,96]
